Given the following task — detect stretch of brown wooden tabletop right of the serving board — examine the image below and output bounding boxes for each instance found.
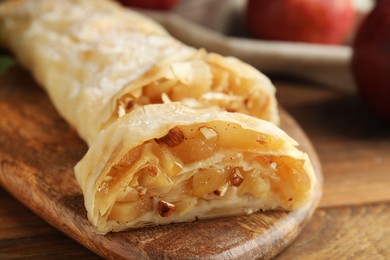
[277,80,390,259]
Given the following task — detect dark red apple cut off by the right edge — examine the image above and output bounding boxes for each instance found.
[352,0,390,120]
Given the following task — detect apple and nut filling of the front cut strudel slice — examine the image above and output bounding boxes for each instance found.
[97,121,310,223]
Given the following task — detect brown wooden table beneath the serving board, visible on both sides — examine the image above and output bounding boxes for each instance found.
[0,80,390,259]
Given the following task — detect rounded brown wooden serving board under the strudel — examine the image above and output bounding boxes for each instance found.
[0,68,322,259]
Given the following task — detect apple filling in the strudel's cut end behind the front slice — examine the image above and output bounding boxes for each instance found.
[114,55,271,120]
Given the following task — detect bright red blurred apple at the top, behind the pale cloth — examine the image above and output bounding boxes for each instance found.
[246,0,356,44]
